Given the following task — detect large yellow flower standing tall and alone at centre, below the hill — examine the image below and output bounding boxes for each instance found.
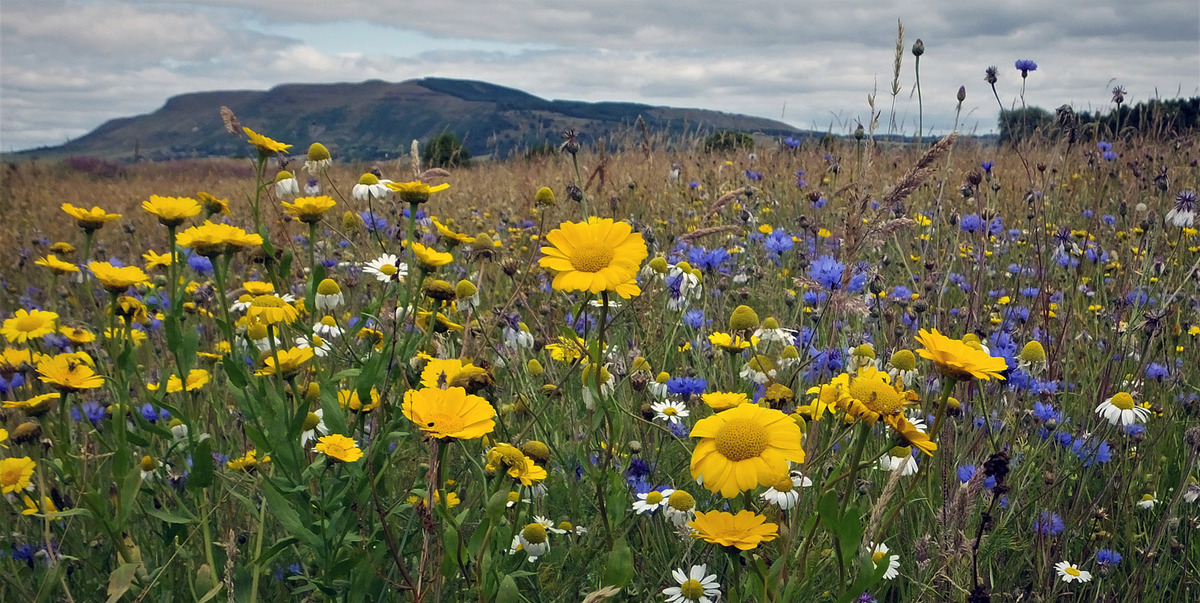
[538,217,649,299]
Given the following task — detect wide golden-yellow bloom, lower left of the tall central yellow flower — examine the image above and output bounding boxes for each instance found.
[402,387,496,440]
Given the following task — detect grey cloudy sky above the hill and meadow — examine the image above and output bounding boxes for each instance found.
[0,0,1200,151]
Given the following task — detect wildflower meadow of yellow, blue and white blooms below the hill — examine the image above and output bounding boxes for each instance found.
[0,120,1200,603]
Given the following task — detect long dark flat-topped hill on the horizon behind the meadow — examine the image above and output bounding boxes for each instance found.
[10,78,812,161]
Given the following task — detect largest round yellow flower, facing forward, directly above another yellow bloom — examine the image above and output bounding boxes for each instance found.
[691,404,804,498]
